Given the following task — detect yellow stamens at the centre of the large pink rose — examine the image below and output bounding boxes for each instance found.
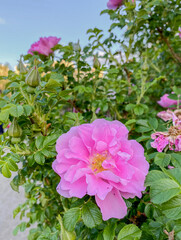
[90,152,108,173]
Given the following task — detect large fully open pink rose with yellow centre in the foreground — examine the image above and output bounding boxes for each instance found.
[53,119,149,220]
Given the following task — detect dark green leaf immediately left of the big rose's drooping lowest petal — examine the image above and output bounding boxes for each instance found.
[82,202,102,228]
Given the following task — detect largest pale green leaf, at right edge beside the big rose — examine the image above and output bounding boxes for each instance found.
[150,179,181,204]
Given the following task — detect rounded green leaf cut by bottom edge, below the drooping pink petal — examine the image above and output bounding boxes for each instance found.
[118,224,142,240]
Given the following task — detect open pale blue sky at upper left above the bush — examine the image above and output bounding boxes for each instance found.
[0,0,110,66]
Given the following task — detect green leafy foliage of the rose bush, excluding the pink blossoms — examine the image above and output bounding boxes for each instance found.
[0,0,181,240]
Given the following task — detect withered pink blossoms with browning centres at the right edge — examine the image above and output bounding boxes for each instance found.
[151,110,181,152]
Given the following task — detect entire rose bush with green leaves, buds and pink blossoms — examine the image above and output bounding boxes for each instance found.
[0,0,181,240]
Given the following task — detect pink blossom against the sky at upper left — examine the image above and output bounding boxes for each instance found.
[28,37,61,56]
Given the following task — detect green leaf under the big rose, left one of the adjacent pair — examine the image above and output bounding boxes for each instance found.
[63,207,81,232]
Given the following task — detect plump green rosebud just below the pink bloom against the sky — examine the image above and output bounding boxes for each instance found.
[25,66,40,87]
